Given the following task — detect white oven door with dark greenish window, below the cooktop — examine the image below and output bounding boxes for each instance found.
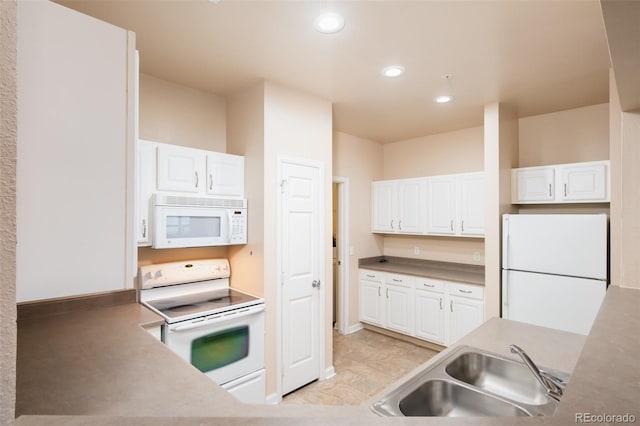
[165,304,264,385]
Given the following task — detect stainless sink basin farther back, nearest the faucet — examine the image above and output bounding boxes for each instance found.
[445,352,549,405]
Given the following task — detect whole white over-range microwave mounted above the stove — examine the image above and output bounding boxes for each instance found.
[152,194,247,248]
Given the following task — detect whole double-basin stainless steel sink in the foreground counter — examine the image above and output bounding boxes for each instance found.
[371,346,569,417]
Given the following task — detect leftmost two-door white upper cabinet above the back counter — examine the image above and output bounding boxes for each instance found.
[371,178,426,234]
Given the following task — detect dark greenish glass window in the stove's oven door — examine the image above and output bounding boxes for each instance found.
[191,325,249,373]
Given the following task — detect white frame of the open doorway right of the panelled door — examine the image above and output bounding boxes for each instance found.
[333,176,351,334]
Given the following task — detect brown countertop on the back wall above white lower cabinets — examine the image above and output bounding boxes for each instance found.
[358,256,484,286]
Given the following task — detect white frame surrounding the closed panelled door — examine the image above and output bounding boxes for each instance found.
[274,155,324,401]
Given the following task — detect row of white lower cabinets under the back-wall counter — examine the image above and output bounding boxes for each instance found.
[360,269,484,346]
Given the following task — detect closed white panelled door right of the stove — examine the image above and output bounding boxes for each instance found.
[280,162,324,395]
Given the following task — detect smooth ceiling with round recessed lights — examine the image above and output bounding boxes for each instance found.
[59,0,610,142]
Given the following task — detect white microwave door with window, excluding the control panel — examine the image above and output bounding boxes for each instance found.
[153,205,231,248]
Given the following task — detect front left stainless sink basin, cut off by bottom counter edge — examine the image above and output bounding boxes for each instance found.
[400,380,529,417]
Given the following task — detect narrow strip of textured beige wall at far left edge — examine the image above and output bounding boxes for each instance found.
[0,0,17,425]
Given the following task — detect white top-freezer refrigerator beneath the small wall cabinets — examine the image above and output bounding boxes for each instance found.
[502,214,607,335]
